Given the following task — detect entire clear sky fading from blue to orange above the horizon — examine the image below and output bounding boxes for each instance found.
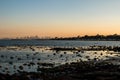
[0,0,120,38]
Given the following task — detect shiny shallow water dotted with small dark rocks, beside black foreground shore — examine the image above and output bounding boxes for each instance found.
[0,46,118,74]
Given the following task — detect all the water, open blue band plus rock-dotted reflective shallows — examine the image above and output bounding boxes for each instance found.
[0,40,120,74]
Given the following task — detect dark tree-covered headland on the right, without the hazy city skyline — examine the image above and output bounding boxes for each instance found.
[52,34,120,41]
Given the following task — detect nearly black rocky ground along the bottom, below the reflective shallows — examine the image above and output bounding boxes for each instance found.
[0,61,120,80]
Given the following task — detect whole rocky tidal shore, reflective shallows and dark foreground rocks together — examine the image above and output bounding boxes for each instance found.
[0,42,120,80]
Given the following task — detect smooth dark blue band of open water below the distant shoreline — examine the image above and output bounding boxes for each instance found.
[0,40,120,47]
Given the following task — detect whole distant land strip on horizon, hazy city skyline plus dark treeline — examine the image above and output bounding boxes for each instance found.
[3,34,120,41]
